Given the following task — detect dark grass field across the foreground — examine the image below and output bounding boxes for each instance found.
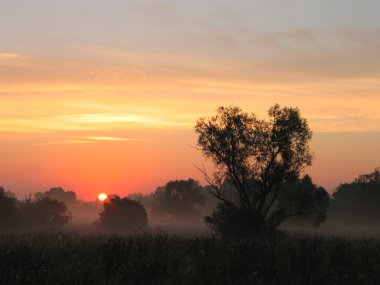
[0,232,380,284]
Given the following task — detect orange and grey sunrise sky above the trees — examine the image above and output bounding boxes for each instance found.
[0,0,380,200]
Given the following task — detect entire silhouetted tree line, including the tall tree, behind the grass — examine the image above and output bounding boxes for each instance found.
[0,104,380,237]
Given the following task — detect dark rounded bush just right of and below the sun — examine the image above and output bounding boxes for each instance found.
[97,195,148,231]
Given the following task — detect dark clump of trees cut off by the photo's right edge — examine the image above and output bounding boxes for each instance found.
[330,168,380,226]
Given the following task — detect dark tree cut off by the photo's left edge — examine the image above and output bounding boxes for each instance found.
[0,187,20,230]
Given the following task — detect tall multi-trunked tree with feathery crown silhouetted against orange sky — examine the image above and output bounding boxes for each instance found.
[195,104,326,236]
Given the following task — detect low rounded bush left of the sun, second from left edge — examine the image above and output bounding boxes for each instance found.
[21,197,72,229]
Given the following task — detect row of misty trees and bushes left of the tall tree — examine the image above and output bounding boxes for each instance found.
[0,179,216,231]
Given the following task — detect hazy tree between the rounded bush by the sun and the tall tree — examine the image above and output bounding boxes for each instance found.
[152,179,205,221]
